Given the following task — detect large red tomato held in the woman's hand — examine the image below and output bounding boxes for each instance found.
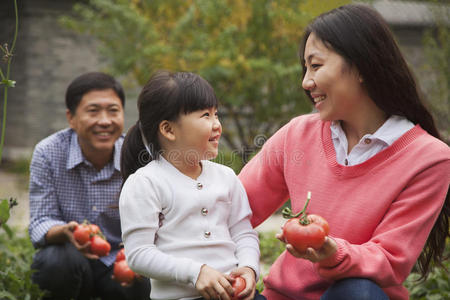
[283,215,329,252]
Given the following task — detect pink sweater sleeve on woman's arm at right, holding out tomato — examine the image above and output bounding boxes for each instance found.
[316,161,450,287]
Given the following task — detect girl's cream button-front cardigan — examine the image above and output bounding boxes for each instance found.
[120,157,259,299]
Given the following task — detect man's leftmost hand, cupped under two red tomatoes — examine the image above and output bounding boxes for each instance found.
[45,221,99,259]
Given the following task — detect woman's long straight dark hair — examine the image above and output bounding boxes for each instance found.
[300,4,450,278]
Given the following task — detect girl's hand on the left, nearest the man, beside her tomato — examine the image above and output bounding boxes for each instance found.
[195,265,233,300]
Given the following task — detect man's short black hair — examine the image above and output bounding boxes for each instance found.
[66,72,125,115]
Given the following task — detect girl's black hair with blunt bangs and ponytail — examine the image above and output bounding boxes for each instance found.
[120,70,218,182]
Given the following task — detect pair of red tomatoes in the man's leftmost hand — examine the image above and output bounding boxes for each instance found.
[73,222,111,256]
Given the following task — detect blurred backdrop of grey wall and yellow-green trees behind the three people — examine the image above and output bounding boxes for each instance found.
[0,0,450,171]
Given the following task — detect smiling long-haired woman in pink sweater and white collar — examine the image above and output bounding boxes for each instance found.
[239,5,450,300]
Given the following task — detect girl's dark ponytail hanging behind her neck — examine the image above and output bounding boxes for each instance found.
[120,121,152,182]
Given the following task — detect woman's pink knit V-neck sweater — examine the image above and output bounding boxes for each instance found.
[239,114,450,300]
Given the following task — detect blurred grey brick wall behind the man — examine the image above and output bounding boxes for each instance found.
[0,0,137,159]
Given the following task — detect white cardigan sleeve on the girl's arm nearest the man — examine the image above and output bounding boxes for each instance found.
[119,175,202,286]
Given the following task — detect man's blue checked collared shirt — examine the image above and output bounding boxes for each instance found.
[29,129,123,266]
